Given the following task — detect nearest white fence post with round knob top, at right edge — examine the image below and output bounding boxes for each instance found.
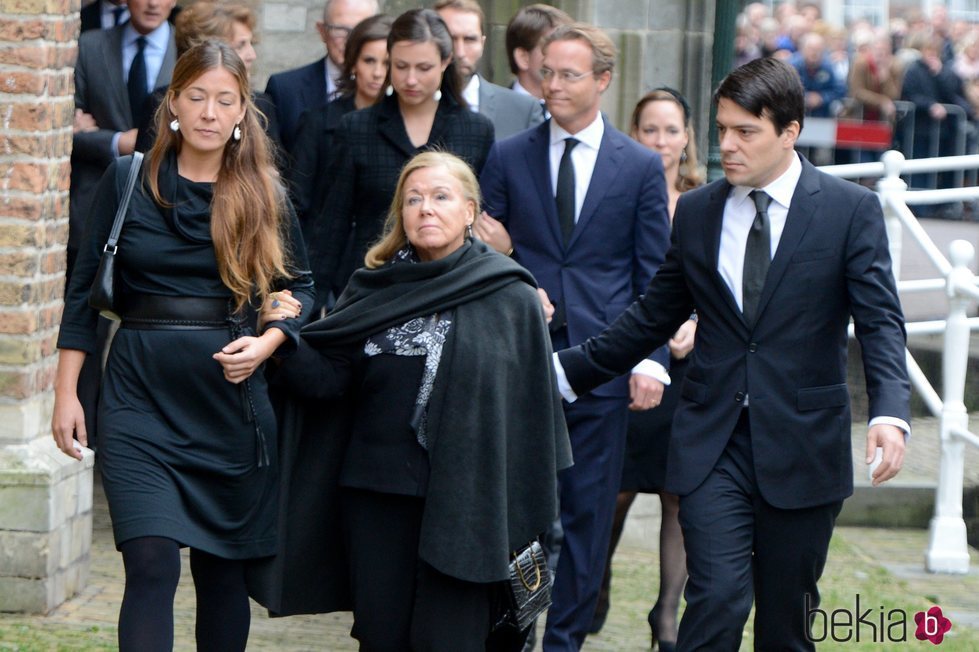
[925,240,975,574]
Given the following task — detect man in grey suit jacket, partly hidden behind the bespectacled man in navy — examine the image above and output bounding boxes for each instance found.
[432,0,544,140]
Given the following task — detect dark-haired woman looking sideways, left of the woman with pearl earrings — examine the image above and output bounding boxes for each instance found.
[289,14,394,233]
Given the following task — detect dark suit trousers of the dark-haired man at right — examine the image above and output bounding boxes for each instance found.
[677,410,843,652]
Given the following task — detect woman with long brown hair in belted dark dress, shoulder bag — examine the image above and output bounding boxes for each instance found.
[52,41,313,651]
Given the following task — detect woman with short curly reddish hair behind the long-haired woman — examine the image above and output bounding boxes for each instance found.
[136,0,280,153]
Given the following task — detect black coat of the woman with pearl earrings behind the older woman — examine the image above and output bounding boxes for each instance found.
[306,95,494,289]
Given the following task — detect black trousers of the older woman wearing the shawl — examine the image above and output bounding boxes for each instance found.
[342,489,526,652]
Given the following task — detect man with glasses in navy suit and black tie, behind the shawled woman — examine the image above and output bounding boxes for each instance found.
[478,23,669,650]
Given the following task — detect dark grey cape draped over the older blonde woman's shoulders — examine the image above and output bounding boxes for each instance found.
[249,241,571,615]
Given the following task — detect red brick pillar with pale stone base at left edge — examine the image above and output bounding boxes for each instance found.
[0,0,93,613]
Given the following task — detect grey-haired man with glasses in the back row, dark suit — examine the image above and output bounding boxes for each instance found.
[265,0,379,152]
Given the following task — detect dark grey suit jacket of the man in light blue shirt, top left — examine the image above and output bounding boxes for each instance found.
[68,25,177,268]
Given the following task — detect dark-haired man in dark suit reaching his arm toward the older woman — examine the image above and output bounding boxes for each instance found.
[557,59,910,651]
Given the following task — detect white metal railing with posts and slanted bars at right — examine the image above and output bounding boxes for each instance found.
[820,151,979,574]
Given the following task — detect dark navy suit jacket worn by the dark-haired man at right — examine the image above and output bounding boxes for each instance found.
[560,159,910,509]
